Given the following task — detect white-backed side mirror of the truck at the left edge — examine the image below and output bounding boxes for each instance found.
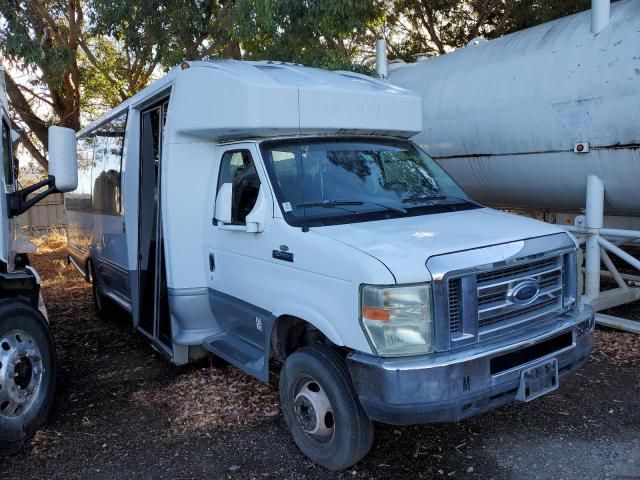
[49,126,78,192]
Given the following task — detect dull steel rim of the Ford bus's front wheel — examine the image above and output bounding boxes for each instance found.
[293,378,335,444]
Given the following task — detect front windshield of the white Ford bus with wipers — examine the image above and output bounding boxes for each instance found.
[261,137,478,225]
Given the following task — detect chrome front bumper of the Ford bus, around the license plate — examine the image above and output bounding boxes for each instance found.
[347,307,594,425]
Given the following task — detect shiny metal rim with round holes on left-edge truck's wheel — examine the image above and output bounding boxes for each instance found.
[0,330,44,418]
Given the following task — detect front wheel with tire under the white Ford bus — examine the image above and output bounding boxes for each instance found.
[280,345,373,470]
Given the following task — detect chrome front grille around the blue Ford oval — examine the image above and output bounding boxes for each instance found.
[447,255,565,342]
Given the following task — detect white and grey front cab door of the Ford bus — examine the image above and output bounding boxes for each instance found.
[205,144,273,377]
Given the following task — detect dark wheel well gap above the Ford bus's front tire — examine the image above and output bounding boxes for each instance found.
[271,315,335,362]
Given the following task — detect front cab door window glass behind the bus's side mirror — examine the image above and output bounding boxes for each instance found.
[217,150,260,225]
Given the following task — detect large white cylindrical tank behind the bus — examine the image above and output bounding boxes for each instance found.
[389,0,640,215]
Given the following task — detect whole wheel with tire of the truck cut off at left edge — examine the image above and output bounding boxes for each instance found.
[0,301,56,455]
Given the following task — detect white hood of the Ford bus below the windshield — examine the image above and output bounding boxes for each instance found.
[313,208,563,283]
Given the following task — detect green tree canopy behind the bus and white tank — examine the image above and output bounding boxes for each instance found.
[0,0,590,165]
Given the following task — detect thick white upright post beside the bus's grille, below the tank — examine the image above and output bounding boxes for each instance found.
[584,175,604,303]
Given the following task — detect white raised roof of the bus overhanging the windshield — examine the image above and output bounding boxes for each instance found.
[81,60,422,143]
